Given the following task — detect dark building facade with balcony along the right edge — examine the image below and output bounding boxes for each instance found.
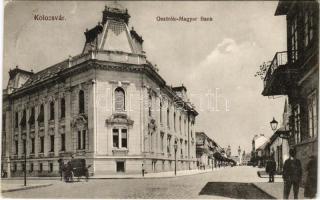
[262,0,319,183]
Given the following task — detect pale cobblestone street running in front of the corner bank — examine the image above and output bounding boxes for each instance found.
[3,166,280,198]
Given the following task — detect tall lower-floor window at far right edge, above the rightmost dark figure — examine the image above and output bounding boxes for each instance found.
[308,93,318,138]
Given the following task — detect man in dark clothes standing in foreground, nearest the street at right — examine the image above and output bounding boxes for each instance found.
[282,149,302,199]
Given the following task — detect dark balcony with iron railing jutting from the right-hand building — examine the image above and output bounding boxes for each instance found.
[262,51,297,96]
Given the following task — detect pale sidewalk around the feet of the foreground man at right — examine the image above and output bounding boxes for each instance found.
[253,182,304,199]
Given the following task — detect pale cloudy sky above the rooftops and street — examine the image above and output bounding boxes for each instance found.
[2,1,286,154]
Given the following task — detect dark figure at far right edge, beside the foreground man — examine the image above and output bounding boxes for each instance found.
[304,155,318,199]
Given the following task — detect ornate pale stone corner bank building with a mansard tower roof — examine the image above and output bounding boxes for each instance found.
[1,6,198,177]
